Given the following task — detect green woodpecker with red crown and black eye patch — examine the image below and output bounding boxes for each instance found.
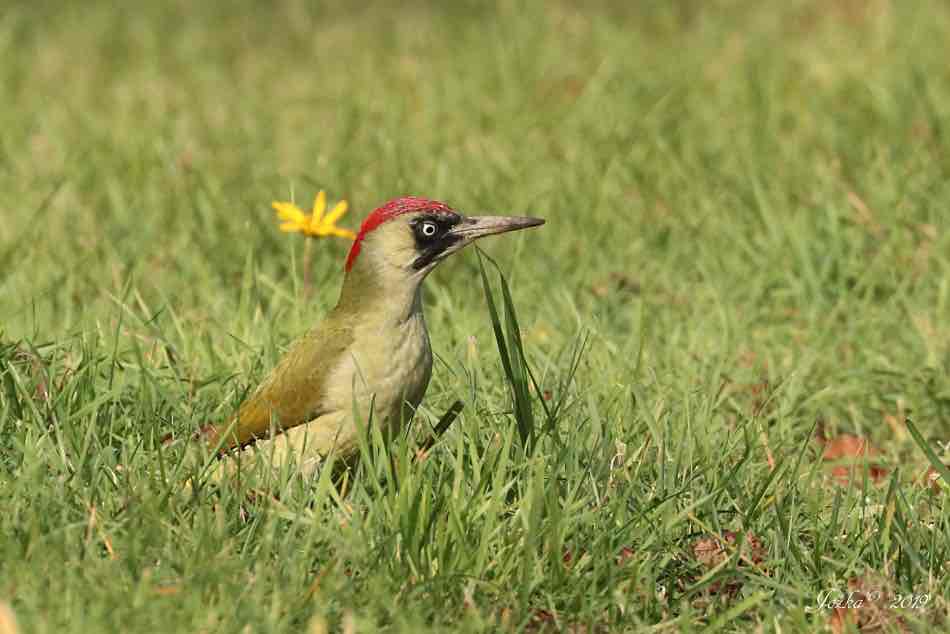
[204,197,544,474]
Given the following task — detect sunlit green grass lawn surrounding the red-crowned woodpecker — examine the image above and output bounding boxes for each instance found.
[0,0,950,633]
